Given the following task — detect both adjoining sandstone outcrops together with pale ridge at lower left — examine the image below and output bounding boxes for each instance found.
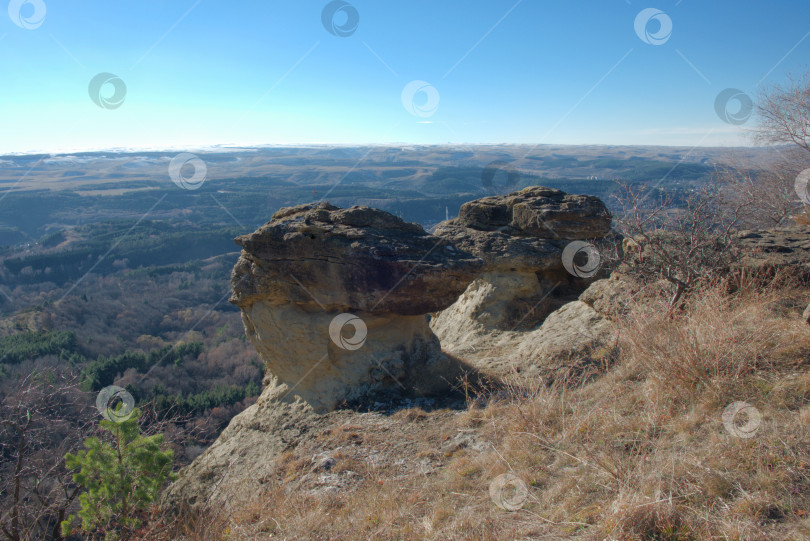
[161,188,614,511]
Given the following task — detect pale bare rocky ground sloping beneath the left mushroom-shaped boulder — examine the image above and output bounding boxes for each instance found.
[161,388,468,516]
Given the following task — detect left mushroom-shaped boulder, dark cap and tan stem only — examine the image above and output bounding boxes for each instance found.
[231,203,483,412]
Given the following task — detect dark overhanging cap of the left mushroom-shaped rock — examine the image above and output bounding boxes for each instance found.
[231,203,481,315]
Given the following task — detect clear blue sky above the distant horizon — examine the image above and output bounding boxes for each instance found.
[0,0,810,153]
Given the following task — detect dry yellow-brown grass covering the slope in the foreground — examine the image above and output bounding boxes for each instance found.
[145,276,810,541]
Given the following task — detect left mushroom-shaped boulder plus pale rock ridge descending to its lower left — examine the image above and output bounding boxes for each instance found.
[161,203,483,512]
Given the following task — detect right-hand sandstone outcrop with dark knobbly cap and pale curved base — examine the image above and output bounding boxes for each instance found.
[431,186,611,371]
